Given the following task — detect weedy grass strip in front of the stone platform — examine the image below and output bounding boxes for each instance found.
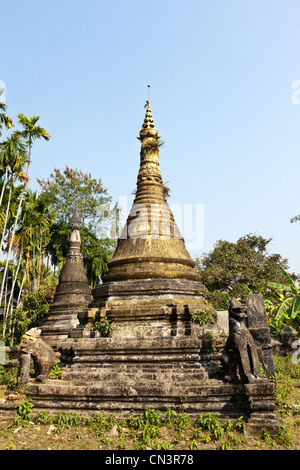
[0,357,300,450]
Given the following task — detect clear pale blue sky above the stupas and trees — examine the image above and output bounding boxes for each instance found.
[0,0,300,274]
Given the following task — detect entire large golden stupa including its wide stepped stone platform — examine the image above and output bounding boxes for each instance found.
[10,88,277,430]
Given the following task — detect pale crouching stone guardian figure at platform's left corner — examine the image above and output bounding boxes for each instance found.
[18,328,57,384]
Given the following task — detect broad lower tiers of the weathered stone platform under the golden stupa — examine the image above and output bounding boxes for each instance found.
[21,334,278,432]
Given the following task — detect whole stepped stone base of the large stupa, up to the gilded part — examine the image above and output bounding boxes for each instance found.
[11,299,278,433]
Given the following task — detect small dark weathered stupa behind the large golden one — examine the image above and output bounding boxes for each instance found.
[42,206,92,346]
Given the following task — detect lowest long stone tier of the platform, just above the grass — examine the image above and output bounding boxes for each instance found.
[23,379,252,419]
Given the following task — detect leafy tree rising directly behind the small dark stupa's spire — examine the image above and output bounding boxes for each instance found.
[38,166,117,287]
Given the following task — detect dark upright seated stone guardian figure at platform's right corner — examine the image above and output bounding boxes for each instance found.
[221,299,263,383]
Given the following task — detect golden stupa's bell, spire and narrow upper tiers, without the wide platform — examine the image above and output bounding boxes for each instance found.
[88,90,206,337]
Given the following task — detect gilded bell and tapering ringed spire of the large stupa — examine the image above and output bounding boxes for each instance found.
[102,89,199,283]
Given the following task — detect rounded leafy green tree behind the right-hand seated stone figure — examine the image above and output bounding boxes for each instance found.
[196,234,288,308]
